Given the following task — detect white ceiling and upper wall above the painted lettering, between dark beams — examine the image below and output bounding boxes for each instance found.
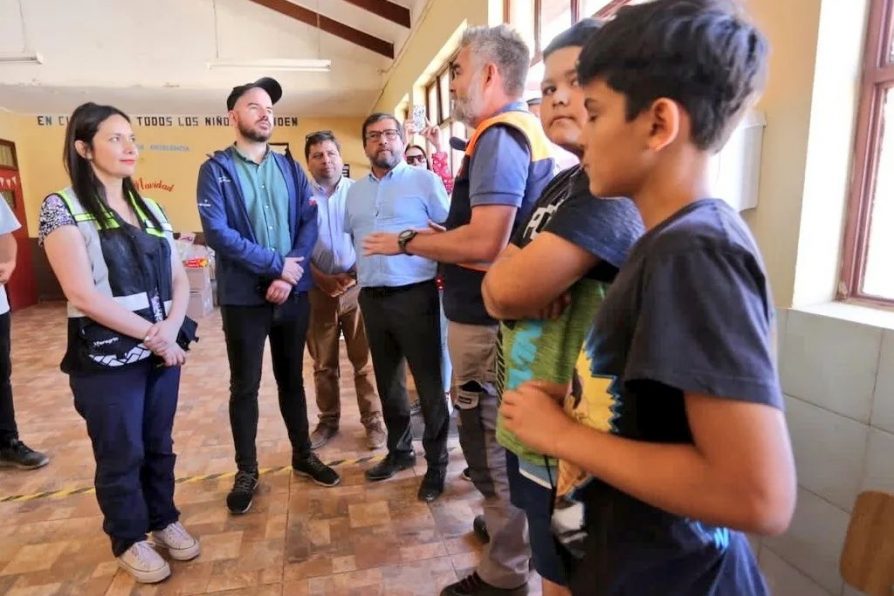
[0,0,428,117]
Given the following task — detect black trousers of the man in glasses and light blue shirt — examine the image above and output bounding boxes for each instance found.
[360,280,449,469]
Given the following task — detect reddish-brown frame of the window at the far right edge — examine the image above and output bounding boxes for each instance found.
[837,0,894,307]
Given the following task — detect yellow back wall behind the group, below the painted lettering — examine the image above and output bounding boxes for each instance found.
[0,112,369,237]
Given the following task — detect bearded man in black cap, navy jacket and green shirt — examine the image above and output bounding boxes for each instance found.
[197,77,340,513]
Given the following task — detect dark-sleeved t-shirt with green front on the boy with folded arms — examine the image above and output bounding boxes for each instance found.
[497,166,643,485]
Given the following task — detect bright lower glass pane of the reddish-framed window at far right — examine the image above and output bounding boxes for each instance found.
[862,88,894,299]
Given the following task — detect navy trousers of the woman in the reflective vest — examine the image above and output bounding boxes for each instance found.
[69,359,180,557]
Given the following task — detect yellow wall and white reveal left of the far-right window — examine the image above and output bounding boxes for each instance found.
[744,0,868,308]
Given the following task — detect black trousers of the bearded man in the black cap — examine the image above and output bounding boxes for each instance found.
[220,292,310,471]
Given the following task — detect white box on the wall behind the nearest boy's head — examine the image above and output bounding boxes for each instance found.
[710,110,767,211]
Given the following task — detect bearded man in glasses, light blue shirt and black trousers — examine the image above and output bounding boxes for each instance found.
[345,113,448,501]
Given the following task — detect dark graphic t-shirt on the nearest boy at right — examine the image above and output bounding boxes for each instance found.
[553,199,783,595]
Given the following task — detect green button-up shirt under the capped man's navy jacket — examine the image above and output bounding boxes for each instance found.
[230,145,292,256]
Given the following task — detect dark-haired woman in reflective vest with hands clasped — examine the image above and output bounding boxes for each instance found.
[39,103,199,583]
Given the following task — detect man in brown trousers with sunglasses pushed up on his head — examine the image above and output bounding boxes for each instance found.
[304,130,385,449]
